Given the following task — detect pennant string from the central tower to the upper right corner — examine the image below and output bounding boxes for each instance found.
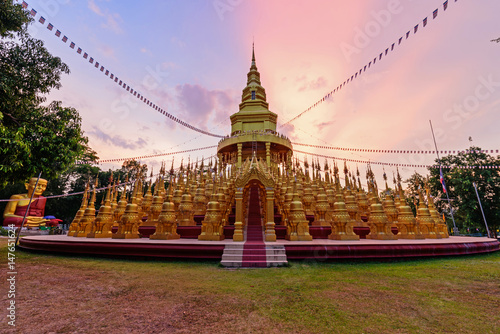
[280,0,458,128]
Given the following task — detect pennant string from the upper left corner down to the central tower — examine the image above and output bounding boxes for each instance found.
[16,0,224,138]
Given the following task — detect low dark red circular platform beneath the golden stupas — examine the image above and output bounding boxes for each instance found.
[19,235,500,261]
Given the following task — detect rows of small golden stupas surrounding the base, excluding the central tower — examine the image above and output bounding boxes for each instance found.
[68,158,448,241]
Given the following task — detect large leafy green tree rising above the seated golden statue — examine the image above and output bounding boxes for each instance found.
[0,1,88,186]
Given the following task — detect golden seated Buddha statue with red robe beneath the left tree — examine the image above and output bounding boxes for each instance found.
[3,177,59,228]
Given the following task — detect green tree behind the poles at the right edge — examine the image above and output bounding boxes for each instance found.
[429,147,500,235]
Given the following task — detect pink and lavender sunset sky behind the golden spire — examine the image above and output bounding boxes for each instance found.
[22,0,500,183]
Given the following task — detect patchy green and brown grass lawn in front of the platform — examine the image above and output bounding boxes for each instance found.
[0,238,500,334]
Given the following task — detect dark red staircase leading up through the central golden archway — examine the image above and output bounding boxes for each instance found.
[241,187,267,268]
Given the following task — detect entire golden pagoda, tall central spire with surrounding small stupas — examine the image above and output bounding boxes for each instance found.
[68,45,448,241]
